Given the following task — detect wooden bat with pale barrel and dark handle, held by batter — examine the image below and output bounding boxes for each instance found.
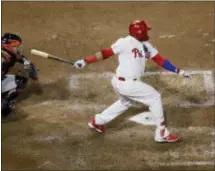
[31,49,74,65]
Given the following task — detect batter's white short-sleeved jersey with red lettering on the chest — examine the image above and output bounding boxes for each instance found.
[111,35,158,79]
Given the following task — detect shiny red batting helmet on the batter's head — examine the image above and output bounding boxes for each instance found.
[129,20,152,41]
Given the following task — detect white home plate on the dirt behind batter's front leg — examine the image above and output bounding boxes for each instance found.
[129,112,155,125]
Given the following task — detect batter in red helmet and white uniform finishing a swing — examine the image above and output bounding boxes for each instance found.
[75,20,191,142]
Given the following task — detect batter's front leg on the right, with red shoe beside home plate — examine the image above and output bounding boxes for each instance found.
[122,81,179,142]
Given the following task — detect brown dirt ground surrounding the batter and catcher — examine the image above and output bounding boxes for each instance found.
[2,2,215,170]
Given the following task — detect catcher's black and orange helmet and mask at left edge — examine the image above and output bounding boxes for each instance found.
[1,33,23,55]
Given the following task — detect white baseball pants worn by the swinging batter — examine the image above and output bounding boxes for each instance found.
[95,76,168,139]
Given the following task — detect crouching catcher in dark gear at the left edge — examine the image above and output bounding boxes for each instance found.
[1,33,38,116]
